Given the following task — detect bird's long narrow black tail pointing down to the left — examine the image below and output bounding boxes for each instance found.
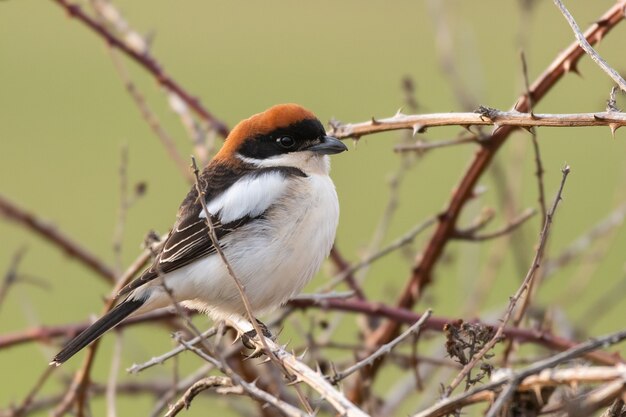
[50,299,145,366]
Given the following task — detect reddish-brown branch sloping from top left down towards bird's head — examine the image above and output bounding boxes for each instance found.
[53,0,228,137]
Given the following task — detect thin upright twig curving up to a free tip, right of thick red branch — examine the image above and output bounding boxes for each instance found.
[444,166,570,397]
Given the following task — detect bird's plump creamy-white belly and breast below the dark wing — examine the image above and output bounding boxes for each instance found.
[166,175,339,319]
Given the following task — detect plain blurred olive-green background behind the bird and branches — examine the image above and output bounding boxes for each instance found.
[0,0,626,415]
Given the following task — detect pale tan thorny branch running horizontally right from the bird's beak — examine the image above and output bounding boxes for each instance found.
[331,106,626,142]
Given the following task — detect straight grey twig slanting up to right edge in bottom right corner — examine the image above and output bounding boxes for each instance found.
[413,324,626,417]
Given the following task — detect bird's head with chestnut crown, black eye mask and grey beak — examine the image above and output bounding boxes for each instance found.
[215,104,348,172]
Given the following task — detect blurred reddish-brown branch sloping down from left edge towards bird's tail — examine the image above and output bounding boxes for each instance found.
[0,195,115,283]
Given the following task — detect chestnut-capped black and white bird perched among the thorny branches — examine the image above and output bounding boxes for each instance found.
[50,103,348,366]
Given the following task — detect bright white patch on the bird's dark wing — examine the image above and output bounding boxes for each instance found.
[199,171,287,224]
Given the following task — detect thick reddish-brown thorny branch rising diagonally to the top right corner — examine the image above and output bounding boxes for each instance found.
[350,2,624,403]
